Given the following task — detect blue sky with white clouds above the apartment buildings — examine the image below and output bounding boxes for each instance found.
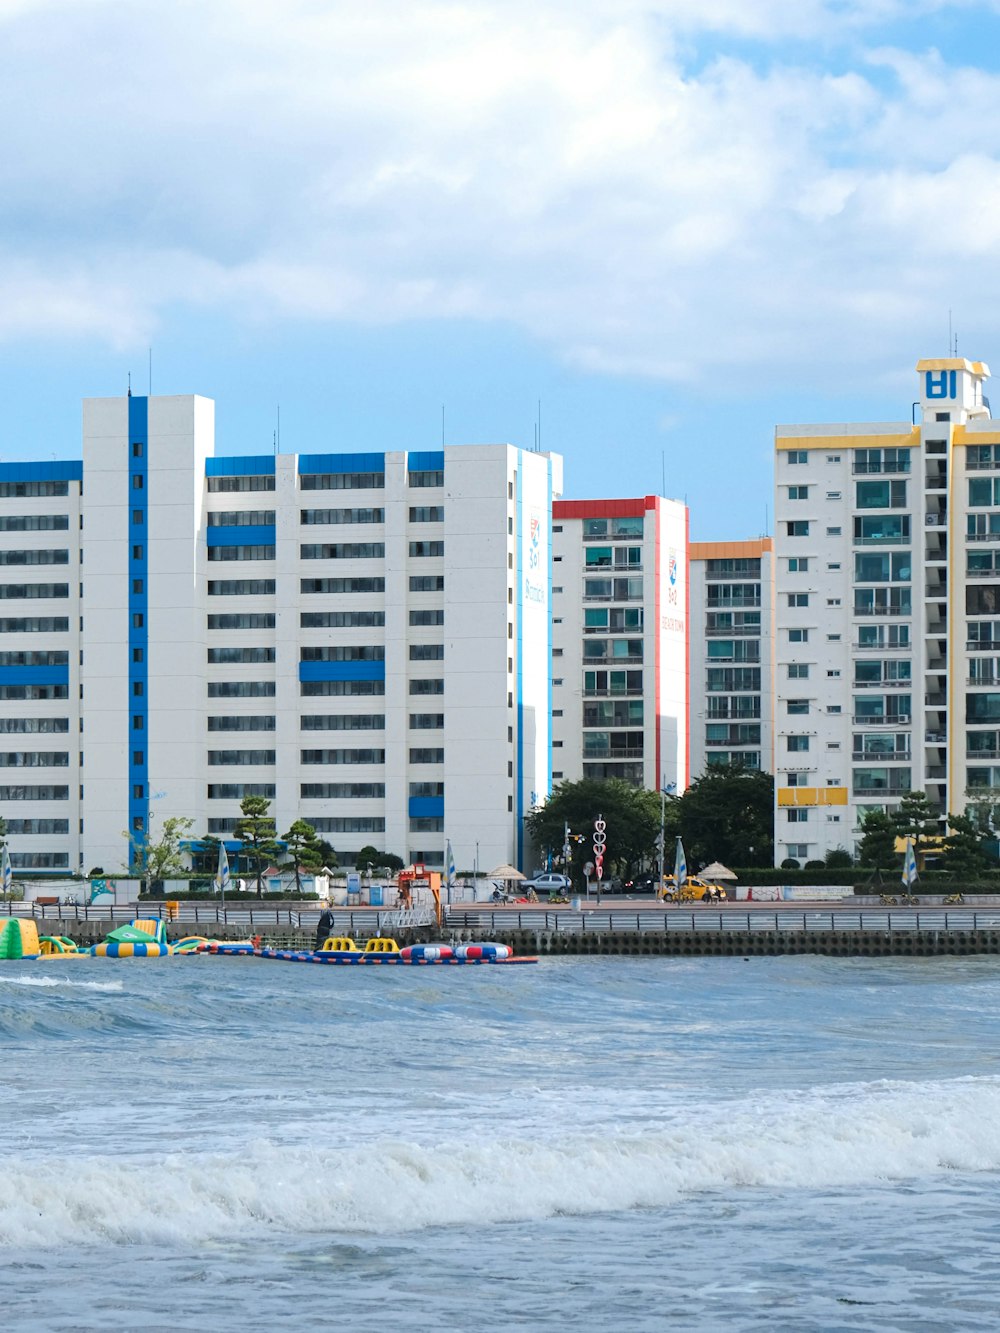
[0,0,1000,540]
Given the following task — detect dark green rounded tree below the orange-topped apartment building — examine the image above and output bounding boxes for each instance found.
[679,764,775,866]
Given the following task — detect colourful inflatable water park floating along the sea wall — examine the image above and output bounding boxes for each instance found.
[0,917,539,966]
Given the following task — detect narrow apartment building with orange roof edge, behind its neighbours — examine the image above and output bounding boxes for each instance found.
[691,537,775,777]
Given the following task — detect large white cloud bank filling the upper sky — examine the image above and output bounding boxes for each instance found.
[0,0,1000,389]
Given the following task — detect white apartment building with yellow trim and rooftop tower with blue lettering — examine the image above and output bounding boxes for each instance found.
[775,357,1000,861]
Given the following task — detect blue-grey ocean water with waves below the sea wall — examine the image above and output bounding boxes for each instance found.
[0,957,1000,1333]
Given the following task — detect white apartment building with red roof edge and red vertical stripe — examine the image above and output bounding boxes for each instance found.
[552,496,689,792]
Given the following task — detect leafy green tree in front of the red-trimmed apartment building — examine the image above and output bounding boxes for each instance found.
[524,777,675,880]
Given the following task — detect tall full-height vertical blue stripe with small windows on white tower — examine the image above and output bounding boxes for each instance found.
[127,397,148,836]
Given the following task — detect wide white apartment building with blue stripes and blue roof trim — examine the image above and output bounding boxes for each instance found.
[0,396,563,873]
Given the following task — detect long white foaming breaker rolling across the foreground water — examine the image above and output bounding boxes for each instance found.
[0,1078,1000,1246]
